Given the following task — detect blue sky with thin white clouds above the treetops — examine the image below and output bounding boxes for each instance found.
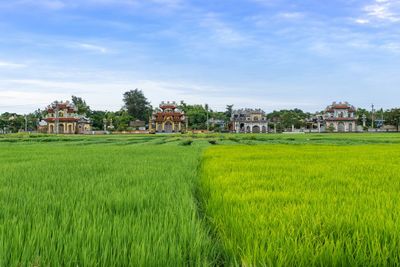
[0,0,400,113]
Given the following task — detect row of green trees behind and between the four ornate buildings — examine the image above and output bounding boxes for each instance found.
[0,89,400,133]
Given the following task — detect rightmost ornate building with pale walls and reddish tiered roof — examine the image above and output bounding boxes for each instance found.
[323,102,357,132]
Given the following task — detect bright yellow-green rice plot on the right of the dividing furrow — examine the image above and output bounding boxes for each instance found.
[202,145,400,266]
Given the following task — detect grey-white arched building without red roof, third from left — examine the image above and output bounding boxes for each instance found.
[231,109,268,133]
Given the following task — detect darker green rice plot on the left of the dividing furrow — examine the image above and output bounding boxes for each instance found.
[0,141,218,266]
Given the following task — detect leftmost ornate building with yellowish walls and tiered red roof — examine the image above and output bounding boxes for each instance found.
[43,101,92,134]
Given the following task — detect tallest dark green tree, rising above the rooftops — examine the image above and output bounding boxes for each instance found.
[123,89,152,122]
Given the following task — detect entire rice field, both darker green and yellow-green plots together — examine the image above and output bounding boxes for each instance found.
[0,134,400,266]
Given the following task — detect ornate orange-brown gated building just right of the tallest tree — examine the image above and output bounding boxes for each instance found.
[149,101,186,133]
